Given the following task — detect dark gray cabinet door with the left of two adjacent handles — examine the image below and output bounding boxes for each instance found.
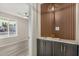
[54,42,63,56]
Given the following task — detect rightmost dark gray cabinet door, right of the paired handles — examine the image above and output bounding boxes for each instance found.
[63,44,77,56]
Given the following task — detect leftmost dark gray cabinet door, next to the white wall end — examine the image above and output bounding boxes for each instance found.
[37,39,45,56]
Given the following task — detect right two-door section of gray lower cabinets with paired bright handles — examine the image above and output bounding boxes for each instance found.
[53,42,77,56]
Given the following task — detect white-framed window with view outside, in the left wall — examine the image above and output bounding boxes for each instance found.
[0,16,17,38]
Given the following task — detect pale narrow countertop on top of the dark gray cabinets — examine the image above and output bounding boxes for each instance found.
[38,37,79,45]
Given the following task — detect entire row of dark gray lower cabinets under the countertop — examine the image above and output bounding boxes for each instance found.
[37,39,79,56]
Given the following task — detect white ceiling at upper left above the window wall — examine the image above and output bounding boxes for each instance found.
[0,3,29,18]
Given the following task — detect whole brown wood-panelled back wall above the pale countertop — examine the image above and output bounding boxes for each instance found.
[41,3,76,40]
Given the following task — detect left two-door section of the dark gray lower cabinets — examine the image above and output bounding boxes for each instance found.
[37,40,52,56]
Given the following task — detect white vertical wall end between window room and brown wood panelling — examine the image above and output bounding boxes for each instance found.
[29,4,40,56]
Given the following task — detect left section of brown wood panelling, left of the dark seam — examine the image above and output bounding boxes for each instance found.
[41,4,55,37]
